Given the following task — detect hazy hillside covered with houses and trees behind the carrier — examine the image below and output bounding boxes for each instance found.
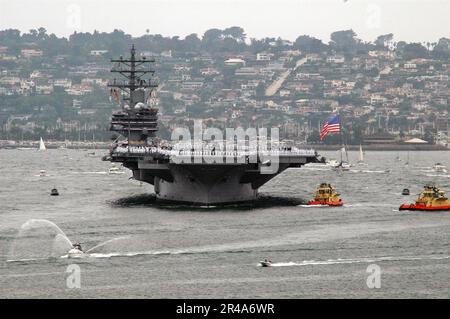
[0,27,450,145]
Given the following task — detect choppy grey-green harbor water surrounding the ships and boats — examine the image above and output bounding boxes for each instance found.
[0,150,450,298]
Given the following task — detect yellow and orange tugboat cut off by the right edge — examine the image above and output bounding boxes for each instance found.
[399,185,450,211]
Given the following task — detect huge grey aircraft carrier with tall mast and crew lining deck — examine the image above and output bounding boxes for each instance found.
[105,46,319,205]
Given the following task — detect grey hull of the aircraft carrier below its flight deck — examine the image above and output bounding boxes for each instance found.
[130,162,308,205]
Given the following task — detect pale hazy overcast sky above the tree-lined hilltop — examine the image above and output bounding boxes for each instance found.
[0,0,450,42]
